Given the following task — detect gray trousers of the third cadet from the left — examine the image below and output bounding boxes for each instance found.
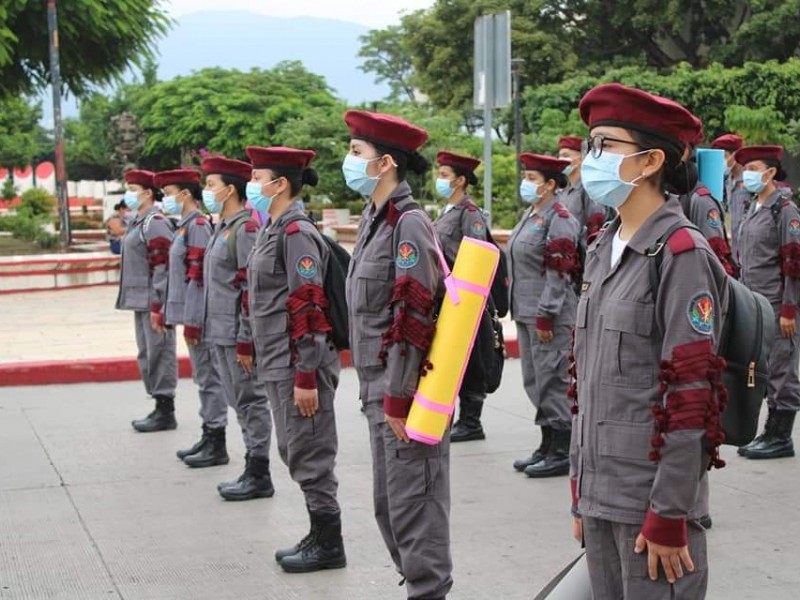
[214,344,272,458]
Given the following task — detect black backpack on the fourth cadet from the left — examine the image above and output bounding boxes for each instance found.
[277,213,350,350]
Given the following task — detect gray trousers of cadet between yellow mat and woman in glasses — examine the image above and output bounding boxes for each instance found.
[515,321,572,431]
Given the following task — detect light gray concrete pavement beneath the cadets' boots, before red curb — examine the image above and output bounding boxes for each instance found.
[0,364,800,600]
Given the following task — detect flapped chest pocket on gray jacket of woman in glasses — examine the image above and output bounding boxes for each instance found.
[598,300,659,389]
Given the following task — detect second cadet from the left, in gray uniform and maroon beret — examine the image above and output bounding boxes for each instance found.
[155,169,228,467]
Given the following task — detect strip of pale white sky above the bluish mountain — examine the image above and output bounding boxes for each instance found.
[163,0,433,27]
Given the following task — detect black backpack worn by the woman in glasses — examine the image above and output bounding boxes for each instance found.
[648,223,776,446]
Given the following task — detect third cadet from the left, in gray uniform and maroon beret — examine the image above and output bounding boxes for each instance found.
[201,156,275,500]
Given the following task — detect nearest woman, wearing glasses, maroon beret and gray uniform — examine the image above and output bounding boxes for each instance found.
[570,84,727,600]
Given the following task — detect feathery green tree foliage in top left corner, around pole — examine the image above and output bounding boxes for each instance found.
[0,0,170,96]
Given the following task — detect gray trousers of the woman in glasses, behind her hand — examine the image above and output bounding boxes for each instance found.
[583,517,708,600]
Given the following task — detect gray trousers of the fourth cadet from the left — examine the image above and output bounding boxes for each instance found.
[266,361,341,514]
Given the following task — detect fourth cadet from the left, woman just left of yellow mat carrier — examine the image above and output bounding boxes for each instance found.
[247,147,347,573]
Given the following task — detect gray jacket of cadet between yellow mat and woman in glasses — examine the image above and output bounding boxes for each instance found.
[507,199,580,331]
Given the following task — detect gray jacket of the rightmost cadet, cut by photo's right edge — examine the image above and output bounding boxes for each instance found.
[739,190,800,319]
